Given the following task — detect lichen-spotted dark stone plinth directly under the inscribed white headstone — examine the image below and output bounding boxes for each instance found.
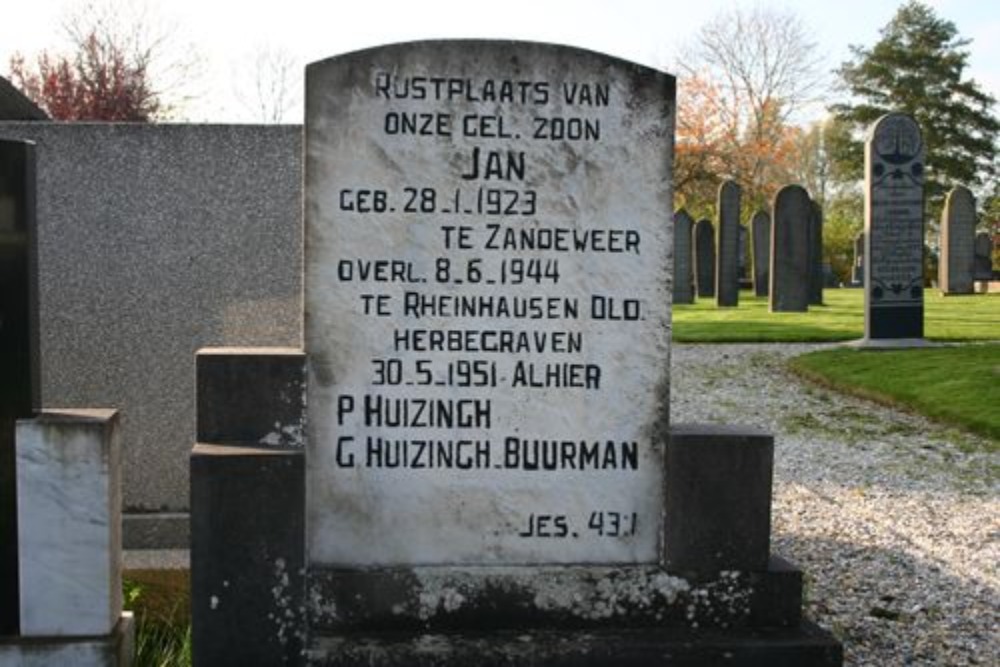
[306,558,802,636]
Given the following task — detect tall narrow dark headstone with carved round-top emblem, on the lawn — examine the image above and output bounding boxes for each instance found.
[865,113,924,339]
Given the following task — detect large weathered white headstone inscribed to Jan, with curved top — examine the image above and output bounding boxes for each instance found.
[305,41,674,567]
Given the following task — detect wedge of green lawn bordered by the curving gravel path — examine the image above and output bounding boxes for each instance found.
[790,344,1000,451]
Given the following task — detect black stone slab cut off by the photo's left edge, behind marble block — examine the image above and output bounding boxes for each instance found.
[0,140,41,636]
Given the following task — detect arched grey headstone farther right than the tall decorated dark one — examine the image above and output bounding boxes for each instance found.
[938,186,976,294]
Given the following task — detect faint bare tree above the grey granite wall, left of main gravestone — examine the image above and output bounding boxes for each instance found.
[233,45,303,123]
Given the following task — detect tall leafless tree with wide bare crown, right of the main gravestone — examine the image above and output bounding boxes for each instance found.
[677,7,827,213]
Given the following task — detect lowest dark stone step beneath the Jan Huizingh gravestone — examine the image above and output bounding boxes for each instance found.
[307,624,843,667]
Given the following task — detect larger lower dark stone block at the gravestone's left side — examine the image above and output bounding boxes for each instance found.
[191,444,305,667]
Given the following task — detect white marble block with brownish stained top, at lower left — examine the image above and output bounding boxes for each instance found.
[17,410,122,637]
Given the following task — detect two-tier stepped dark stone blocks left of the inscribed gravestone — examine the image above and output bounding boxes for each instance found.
[191,349,305,667]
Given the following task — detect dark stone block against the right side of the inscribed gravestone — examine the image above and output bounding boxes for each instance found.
[664,424,774,574]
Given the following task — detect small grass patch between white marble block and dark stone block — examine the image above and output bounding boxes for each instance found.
[124,570,191,667]
